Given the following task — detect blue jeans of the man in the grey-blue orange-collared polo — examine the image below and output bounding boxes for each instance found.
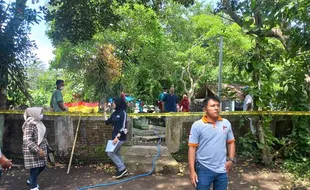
[196,162,228,190]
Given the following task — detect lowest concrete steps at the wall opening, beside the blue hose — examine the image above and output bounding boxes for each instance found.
[121,146,179,174]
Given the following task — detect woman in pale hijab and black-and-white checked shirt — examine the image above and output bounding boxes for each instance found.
[22,107,48,190]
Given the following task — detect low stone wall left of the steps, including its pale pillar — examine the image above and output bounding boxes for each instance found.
[0,115,132,163]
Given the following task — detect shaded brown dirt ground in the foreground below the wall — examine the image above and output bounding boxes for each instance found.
[0,162,310,190]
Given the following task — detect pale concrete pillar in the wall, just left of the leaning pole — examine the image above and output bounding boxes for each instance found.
[54,116,74,156]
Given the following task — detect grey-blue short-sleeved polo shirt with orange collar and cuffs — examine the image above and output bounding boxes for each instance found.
[188,116,235,173]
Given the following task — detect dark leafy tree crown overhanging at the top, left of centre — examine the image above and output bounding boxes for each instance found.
[45,0,194,46]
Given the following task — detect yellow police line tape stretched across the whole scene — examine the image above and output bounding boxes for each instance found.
[0,110,310,117]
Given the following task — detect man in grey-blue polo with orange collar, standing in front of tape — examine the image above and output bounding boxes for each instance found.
[188,97,235,190]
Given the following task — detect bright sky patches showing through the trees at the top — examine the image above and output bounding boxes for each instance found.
[5,0,219,67]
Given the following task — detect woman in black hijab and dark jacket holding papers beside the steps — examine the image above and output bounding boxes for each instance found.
[105,98,128,179]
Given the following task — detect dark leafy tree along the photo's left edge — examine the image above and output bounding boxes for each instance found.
[0,0,39,109]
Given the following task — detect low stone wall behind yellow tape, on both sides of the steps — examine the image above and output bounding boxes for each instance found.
[0,115,292,163]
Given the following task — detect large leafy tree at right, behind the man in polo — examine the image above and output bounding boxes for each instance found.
[218,0,310,164]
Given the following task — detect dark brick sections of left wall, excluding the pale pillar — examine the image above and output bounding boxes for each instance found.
[3,115,116,163]
